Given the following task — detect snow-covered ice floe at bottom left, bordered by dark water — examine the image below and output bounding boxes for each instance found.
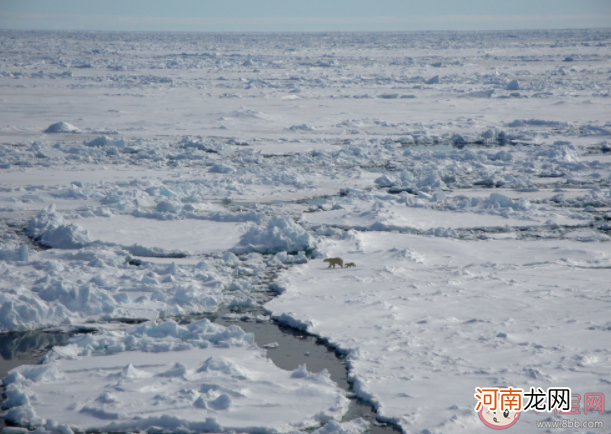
[3,319,350,434]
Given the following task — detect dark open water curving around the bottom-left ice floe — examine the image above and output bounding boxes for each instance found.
[0,314,398,434]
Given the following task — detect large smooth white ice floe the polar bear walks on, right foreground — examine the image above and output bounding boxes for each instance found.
[266,234,611,433]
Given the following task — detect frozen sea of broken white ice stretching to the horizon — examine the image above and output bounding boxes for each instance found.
[0,29,611,434]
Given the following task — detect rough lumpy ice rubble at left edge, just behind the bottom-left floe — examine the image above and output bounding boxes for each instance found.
[0,244,227,332]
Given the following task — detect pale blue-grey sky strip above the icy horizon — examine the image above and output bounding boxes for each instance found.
[0,0,611,32]
